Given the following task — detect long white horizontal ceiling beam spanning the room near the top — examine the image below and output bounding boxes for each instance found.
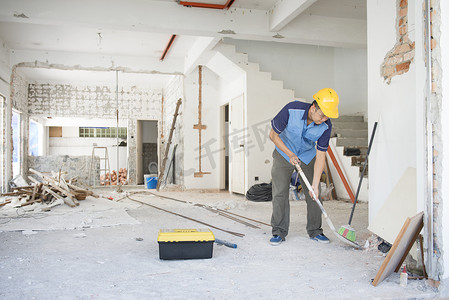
[0,0,366,48]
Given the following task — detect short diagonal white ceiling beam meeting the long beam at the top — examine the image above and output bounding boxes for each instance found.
[270,0,317,32]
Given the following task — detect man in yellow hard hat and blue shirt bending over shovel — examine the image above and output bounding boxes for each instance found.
[270,88,339,245]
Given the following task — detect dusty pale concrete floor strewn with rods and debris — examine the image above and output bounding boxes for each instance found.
[0,188,437,299]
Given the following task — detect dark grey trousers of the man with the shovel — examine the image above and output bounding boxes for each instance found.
[271,149,323,239]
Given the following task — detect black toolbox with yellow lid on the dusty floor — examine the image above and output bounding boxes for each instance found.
[157,229,215,259]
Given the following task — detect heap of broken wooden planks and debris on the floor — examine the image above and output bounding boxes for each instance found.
[0,169,99,207]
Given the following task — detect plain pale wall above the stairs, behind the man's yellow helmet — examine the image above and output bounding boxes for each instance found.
[226,39,367,115]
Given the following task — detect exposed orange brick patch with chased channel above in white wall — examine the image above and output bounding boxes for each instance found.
[381,0,415,84]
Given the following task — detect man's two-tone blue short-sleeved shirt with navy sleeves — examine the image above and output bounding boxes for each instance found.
[271,101,332,164]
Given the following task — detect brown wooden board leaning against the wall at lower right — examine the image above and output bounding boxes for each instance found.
[372,212,424,286]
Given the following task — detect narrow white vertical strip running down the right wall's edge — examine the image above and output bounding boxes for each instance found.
[425,0,438,280]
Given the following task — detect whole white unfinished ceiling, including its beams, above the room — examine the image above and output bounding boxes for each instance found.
[0,0,366,82]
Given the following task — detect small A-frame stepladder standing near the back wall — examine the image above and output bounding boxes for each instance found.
[89,146,112,187]
